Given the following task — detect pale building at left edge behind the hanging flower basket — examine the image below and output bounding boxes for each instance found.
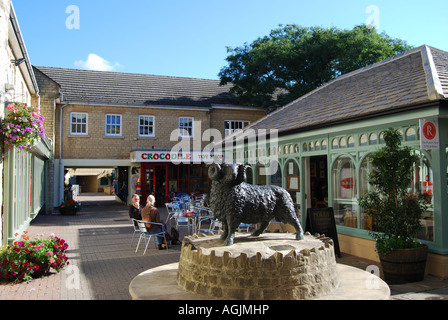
[0,0,52,245]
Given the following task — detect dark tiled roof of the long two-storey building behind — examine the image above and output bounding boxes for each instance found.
[35,67,235,107]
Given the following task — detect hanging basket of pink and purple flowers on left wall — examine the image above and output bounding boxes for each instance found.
[0,103,46,150]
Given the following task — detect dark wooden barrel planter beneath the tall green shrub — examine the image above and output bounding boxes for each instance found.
[379,245,428,284]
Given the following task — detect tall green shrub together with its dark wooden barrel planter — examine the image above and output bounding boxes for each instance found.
[359,129,429,284]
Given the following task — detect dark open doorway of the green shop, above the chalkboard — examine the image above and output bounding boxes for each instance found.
[309,156,328,208]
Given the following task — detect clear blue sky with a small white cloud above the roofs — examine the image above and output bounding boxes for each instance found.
[12,0,448,79]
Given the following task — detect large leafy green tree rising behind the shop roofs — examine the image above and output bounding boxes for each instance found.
[219,25,412,108]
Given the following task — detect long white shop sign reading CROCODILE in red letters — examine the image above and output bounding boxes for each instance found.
[131,150,223,164]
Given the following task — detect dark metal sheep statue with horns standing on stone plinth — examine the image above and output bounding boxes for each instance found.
[208,163,303,246]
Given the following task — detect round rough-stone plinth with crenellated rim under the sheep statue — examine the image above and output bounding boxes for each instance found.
[177,233,340,300]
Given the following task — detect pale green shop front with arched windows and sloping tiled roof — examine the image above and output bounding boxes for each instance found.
[228,46,448,278]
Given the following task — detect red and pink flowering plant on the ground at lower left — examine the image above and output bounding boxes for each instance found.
[0,231,69,282]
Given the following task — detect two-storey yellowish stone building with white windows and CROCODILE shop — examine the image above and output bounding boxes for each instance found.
[34,67,266,207]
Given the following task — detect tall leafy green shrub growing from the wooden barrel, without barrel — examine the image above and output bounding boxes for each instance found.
[359,129,430,254]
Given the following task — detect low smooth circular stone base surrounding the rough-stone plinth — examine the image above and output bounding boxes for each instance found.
[129,263,390,301]
